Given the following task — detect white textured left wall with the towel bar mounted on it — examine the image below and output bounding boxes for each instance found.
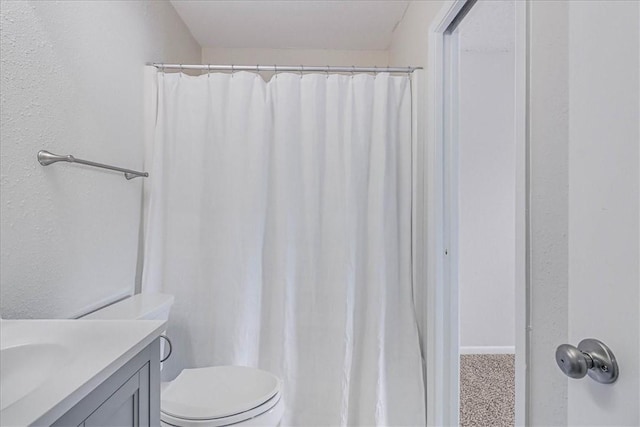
[0,1,201,318]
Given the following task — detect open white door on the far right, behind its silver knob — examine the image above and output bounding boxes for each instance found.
[568,1,640,426]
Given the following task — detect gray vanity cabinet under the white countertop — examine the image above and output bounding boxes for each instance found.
[53,339,160,427]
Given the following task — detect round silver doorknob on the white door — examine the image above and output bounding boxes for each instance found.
[556,338,619,384]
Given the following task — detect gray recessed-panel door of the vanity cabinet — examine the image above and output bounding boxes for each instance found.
[84,364,149,427]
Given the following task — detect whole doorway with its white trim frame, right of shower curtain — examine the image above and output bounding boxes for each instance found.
[426,0,528,426]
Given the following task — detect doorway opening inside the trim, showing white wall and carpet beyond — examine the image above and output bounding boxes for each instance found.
[452,0,518,427]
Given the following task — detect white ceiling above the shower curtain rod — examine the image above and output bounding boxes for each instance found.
[171,0,409,50]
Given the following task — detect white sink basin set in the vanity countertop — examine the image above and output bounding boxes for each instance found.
[0,343,71,411]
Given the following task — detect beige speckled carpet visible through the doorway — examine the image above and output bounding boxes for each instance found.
[460,354,515,427]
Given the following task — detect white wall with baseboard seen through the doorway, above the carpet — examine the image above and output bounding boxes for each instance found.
[458,2,516,353]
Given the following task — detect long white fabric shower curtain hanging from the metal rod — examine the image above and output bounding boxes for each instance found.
[143,73,425,426]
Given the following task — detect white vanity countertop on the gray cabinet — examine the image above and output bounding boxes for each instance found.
[0,319,166,426]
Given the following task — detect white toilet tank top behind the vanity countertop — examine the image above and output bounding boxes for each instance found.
[82,294,178,320]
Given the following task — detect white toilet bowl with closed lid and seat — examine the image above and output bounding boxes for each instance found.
[160,366,282,427]
